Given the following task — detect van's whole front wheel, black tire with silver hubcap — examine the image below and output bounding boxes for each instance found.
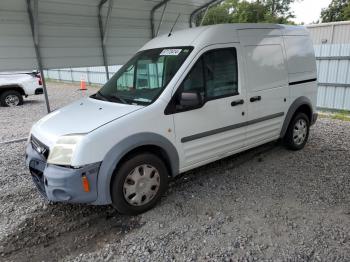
[111,153,169,215]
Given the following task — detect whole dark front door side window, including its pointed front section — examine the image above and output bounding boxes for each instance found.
[181,48,238,100]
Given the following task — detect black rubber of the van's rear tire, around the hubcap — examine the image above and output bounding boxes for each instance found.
[284,113,310,150]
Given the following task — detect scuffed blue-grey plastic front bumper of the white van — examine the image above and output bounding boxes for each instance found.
[26,143,101,203]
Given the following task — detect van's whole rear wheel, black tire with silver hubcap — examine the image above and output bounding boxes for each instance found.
[284,113,310,150]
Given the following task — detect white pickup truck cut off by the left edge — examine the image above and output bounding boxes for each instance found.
[0,71,43,106]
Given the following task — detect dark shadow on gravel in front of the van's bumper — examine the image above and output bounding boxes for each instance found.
[0,204,141,261]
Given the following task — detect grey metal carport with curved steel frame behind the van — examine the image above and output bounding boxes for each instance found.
[0,0,219,112]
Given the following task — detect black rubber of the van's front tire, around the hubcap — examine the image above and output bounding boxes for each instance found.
[111,153,169,215]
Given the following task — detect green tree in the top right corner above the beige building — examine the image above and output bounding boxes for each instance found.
[321,0,350,23]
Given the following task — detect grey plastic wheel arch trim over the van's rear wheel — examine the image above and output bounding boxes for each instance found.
[280,96,314,137]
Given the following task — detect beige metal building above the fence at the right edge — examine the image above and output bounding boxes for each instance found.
[306,21,350,45]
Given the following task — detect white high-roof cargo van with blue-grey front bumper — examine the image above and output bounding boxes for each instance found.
[26,24,317,214]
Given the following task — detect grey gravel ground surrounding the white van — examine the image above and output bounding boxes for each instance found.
[0,81,350,261]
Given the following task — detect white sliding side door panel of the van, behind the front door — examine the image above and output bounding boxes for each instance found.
[239,29,290,145]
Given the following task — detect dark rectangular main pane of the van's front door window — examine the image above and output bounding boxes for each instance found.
[203,48,238,99]
